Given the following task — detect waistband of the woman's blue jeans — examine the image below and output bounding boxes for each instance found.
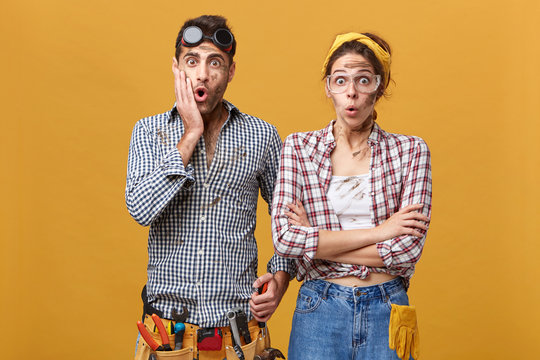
[302,276,406,300]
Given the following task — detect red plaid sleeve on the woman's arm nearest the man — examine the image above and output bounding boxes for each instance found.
[272,135,319,262]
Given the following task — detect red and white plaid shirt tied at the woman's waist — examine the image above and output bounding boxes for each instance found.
[272,122,431,284]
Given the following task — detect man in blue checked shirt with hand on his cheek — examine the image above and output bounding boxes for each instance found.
[126,16,294,360]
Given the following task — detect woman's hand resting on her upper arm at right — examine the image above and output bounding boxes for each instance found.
[375,204,429,241]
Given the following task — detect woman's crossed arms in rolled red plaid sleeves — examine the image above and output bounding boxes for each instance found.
[272,138,431,272]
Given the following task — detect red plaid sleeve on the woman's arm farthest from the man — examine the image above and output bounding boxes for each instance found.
[377,138,431,275]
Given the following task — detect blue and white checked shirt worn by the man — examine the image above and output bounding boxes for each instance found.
[126,102,295,327]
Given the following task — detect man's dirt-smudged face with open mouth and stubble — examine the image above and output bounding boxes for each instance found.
[178,42,235,115]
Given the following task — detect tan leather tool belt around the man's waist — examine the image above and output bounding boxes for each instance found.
[135,287,270,360]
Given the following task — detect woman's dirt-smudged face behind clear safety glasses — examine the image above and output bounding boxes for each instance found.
[326,53,377,129]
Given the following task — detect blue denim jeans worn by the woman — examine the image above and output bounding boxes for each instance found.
[288,277,409,360]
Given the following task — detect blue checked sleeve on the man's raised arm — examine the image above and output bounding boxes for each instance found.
[126,121,195,226]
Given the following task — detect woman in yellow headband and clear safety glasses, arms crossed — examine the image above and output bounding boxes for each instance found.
[272,33,431,360]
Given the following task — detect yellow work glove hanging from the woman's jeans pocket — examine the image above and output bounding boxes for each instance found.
[388,304,420,360]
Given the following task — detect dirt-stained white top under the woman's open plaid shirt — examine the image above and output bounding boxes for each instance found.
[326,173,373,230]
